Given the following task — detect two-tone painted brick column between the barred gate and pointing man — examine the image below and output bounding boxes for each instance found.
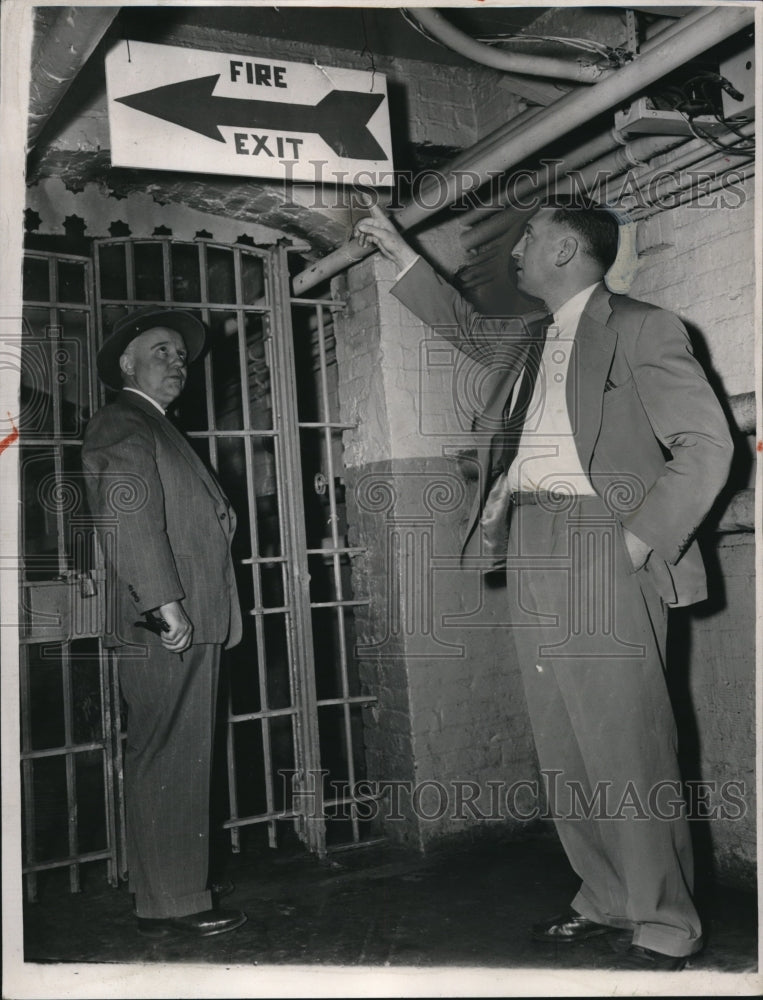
[336,255,537,849]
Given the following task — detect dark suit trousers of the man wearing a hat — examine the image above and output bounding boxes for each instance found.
[117,643,220,918]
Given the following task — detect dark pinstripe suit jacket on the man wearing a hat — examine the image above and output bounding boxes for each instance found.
[82,391,241,646]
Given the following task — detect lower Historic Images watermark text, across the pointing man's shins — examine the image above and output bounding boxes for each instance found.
[278,770,749,823]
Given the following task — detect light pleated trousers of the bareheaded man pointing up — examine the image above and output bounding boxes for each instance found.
[508,496,701,956]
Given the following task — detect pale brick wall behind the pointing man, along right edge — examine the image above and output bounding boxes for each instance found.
[631,180,759,886]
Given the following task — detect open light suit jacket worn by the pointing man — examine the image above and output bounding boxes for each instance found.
[392,260,733,605]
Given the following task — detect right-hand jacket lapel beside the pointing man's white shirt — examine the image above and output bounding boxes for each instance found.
[567,284,617,473]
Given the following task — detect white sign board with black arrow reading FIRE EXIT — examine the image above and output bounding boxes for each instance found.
[106,41,393,187]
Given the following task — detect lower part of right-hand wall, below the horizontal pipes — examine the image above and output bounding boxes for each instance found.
[668,534,756,888]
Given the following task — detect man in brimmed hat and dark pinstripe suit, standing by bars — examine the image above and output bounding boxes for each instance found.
[82,307,246,937]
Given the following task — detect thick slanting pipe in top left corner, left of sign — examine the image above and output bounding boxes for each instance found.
[27,6,120,149]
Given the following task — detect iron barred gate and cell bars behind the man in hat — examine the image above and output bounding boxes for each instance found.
[20,238,380,898]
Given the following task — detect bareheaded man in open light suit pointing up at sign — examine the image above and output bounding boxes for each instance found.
[356,204,732,970]
